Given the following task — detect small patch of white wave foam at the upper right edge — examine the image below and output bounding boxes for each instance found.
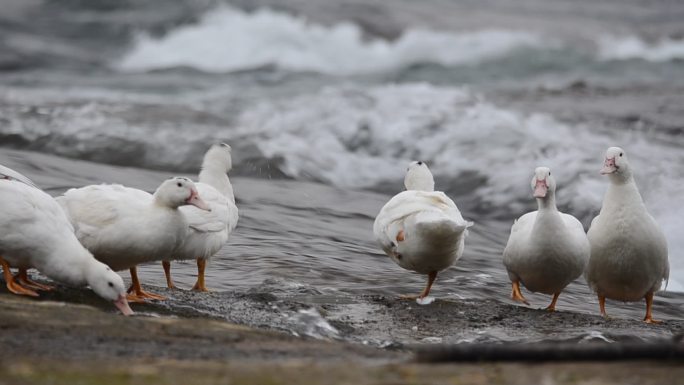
[598,36,684,62]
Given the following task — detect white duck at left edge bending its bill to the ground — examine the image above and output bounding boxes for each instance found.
[0,166,133,315]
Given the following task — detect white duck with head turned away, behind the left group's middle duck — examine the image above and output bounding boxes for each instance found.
[162,143,238,291]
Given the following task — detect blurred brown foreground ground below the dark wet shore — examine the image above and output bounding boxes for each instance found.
[0,294,684,384]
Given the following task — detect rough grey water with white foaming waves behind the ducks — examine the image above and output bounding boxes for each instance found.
[0,0,684,342]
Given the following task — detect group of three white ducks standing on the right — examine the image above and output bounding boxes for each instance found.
[373,147,669,323]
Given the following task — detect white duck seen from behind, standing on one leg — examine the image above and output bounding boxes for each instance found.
[373,162,473,299]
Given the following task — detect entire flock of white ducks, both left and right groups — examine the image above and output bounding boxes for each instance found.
[0,144,669,323]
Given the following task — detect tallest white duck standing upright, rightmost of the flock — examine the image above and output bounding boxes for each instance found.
[585,147,670,323]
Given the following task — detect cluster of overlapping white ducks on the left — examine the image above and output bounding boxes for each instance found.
[0,144,238,315]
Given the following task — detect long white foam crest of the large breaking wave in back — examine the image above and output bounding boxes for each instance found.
[117,7,545,75]
